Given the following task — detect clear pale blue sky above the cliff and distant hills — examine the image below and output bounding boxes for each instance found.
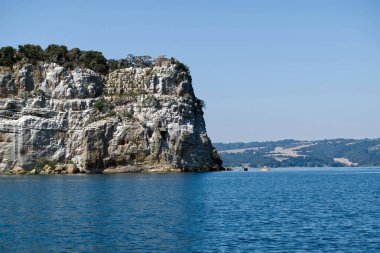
[0,0,380,142]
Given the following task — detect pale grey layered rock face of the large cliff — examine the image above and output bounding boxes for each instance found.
[0,59,221,173]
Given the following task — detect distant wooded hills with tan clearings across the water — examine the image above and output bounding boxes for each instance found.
[214,139,380,167]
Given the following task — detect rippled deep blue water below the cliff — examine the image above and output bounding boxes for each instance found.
[0,168,380,252]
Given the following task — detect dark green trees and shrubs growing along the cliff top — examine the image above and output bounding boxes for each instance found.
[0,44,189,75]
